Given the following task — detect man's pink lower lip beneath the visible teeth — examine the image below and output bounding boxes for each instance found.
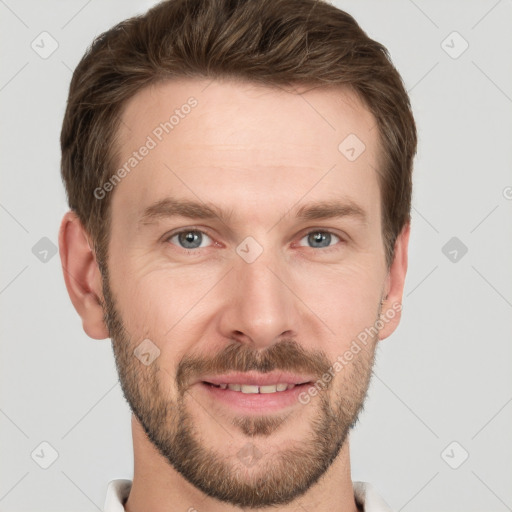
[199,382,311,414]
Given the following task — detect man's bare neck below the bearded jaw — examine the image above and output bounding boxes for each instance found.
[125,415,358,512]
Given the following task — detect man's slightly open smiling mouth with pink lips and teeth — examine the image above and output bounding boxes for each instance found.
[196,373,314,415]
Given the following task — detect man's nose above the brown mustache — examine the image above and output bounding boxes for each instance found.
[219,245,300,350]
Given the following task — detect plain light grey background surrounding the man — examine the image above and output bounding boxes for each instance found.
[0,0,512,512]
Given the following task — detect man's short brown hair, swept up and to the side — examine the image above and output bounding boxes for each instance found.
[61,0,417,268]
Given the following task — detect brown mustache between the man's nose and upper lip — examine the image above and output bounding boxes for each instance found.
[176,340,331,394]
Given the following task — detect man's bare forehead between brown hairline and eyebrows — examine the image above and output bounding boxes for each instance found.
[112,79,380,230]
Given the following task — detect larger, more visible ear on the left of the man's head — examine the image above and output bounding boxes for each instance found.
[59,211,109,340]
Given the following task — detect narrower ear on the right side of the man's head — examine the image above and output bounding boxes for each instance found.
[379,223,411,340]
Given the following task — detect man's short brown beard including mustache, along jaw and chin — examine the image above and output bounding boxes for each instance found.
[102,269,381,508]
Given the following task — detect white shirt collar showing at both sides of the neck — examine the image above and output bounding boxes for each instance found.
[103,480,393,512]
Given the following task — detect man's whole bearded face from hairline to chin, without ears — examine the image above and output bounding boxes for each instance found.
[103,80,387,507]
